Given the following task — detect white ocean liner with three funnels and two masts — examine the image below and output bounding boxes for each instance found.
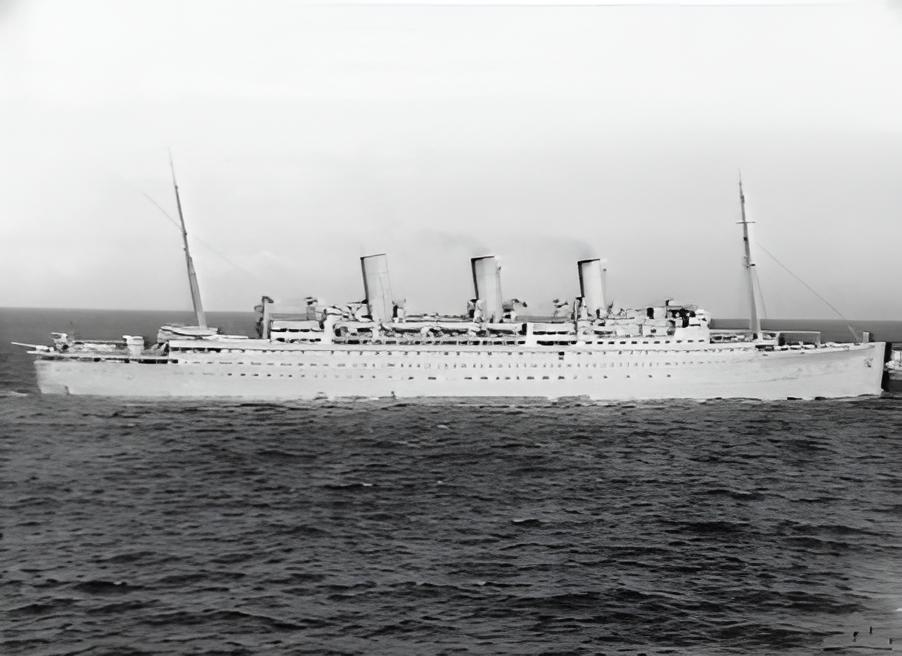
[14,175,887,401]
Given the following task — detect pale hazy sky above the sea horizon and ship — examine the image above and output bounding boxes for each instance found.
[0,0,902,319]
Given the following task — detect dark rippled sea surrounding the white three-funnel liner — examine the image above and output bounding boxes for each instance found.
[0,309,902,656]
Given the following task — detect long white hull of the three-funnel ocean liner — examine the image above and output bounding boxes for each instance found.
[35,340,885,401]
